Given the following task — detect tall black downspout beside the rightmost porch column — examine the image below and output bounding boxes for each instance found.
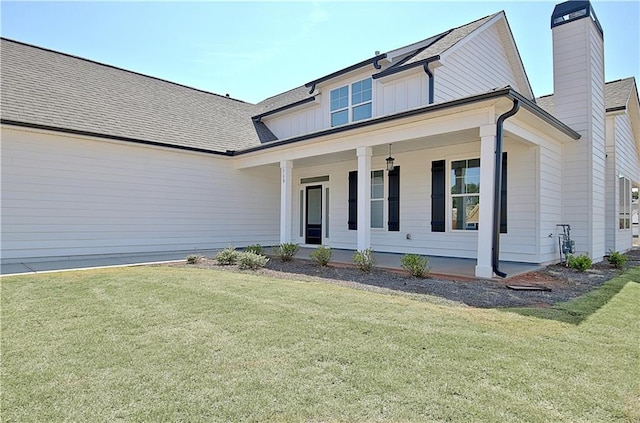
[491,99,520,278]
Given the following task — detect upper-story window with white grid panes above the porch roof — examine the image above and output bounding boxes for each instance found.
[331,78,372,126]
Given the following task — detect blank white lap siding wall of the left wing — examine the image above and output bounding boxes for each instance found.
[2,127,279,262]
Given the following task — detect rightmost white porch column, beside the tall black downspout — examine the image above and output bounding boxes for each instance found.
[476,124,496,278]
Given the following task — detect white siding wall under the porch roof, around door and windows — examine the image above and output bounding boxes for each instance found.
[292,139,540,263]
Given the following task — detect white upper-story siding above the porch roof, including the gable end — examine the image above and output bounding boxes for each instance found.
[263,21,528,143]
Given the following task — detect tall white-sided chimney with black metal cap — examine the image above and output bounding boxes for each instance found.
[551,1,605,262]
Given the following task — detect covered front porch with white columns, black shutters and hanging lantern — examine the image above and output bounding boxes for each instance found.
[235,92,571,278]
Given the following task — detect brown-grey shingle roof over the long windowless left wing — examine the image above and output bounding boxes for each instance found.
[0,39,264,152]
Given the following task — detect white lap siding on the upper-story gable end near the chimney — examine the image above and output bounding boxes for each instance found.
[434,25,526,103]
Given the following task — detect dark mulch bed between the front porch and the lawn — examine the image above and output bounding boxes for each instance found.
[179,250,640,308]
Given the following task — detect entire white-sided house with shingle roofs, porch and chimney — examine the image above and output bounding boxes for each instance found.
[1,2,640,277]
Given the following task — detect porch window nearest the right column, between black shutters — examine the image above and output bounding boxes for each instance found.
[451,159,480,230]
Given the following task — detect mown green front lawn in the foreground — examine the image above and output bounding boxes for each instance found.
[0,267,640,422]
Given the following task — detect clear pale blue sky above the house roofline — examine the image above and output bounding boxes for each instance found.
[0,0,640,103]
